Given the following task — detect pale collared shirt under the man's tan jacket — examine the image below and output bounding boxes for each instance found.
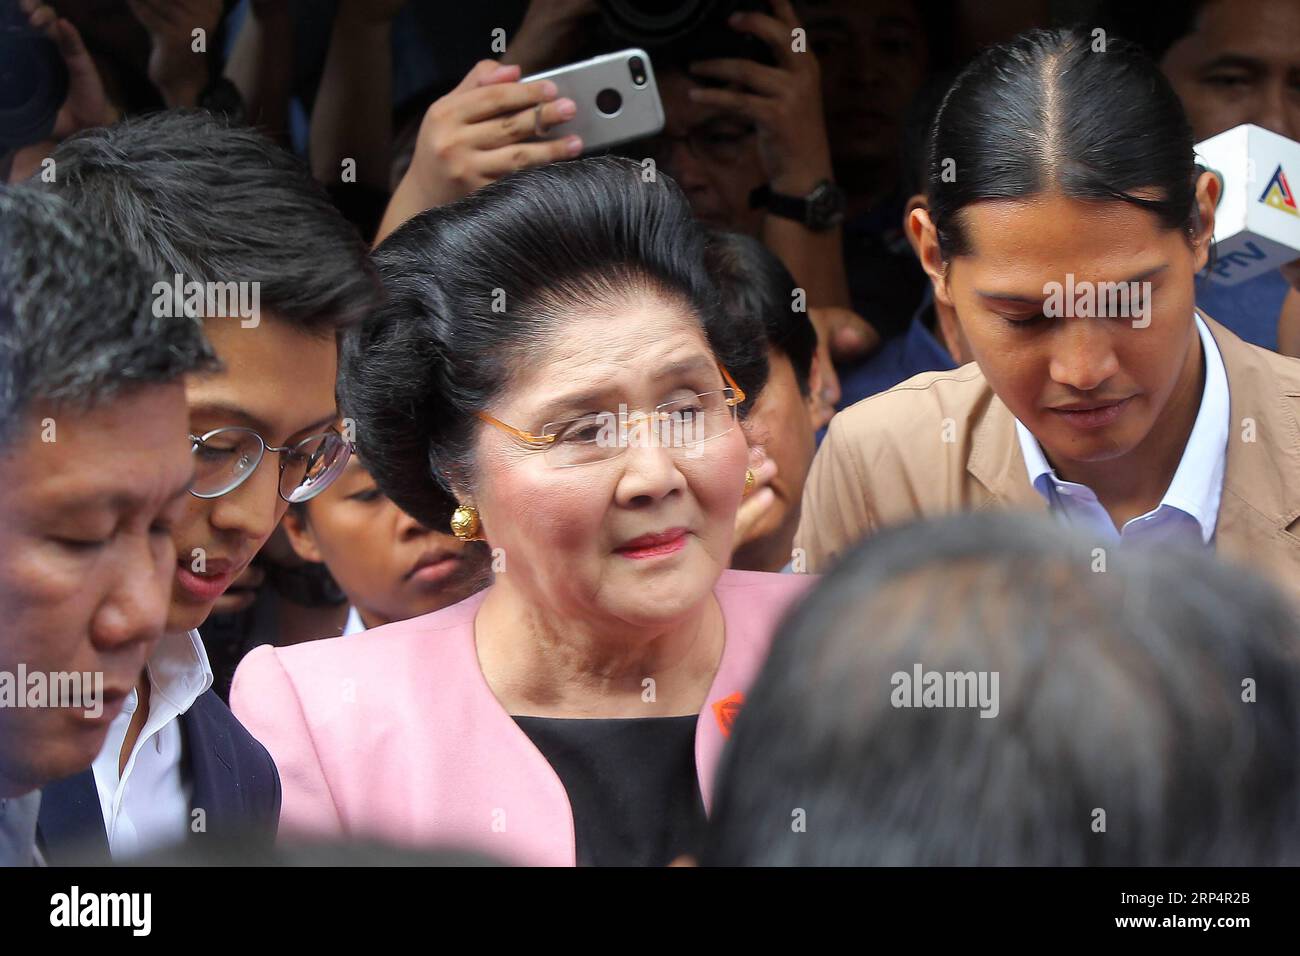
[1015,315,1231,545]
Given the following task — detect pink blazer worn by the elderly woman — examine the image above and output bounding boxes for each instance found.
[230,571,810,866]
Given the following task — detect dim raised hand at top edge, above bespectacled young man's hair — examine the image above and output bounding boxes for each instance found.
[126,0,222,107]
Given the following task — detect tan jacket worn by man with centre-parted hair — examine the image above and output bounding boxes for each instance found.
[794,313,1300,600]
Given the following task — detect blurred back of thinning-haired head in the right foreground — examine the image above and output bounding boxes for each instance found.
[702,515,1300,866]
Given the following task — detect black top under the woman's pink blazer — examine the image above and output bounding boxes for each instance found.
[515,715,705,866]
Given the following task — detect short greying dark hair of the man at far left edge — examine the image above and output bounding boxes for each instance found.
[0,186,215,444]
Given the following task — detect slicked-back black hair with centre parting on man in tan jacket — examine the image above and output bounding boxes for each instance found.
[927,29,1196,258]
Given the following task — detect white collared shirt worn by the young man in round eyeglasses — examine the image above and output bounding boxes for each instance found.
[92,631,212,860]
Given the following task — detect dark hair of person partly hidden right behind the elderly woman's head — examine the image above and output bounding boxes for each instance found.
[706,230,816,407]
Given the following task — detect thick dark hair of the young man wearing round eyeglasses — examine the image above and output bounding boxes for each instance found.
[35,109,377,334]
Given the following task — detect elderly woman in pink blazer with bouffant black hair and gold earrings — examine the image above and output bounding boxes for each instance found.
[231,159,807,865]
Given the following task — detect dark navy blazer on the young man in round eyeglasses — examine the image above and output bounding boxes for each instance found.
[36,691,280,866]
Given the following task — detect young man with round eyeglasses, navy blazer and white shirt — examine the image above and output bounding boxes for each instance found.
[32,111,376,861]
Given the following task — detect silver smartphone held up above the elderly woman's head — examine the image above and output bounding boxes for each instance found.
[520,48,663,153]
